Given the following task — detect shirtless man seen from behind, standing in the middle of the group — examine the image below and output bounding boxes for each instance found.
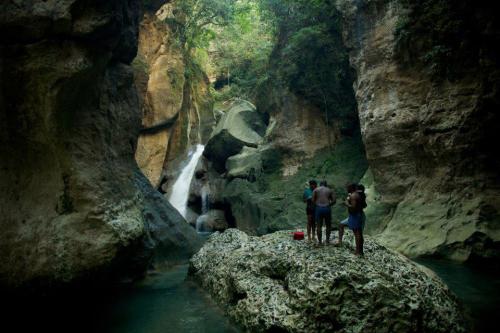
[312,180,336,245]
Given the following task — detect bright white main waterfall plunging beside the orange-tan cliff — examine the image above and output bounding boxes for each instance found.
[168,145,205,217]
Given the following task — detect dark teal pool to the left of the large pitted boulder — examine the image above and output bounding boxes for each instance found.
[0,265,240,333]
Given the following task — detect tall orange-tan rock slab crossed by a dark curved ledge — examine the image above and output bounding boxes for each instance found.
[134,5,185,186]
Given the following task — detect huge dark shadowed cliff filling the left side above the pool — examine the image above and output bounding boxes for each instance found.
[0,0,197,287]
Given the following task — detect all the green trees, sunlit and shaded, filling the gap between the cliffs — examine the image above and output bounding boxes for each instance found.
[167,0,357,129]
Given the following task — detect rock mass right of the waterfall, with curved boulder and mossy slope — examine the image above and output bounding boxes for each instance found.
[190,98,367,235]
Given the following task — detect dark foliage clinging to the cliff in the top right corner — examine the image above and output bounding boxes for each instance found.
[394,0,488,80]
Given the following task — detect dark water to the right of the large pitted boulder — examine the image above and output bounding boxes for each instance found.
[416,258,500,333]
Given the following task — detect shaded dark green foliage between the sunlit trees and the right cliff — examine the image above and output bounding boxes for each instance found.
[261,0,356,126]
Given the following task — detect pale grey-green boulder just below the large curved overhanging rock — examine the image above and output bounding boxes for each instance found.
[226,146,262,180]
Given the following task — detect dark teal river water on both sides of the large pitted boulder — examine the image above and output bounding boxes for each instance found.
[0,255,500,333]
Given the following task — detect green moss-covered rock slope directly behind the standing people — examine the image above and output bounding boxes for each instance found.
[223,138,367,235]
